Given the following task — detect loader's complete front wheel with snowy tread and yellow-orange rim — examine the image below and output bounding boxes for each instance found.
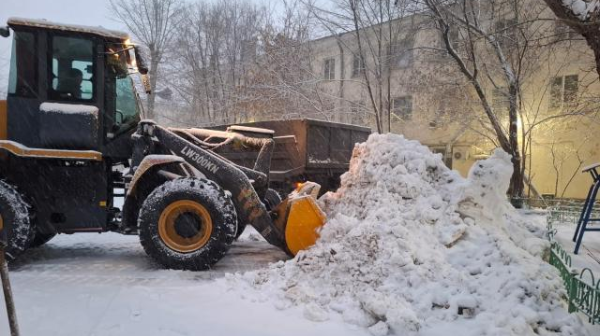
[138,178,237,271]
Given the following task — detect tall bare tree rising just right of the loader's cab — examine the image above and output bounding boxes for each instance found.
[110,0,183,118]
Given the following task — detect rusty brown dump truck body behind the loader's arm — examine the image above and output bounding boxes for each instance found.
[211,119,371,195]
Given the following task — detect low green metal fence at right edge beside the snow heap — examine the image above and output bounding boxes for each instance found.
[548,217,600,324]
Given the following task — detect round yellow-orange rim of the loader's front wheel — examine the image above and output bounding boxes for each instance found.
[158,200,213,253]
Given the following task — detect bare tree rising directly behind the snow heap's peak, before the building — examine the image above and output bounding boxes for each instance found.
[313,0,414,133]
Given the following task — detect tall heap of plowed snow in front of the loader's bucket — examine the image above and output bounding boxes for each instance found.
[229,134,586,335]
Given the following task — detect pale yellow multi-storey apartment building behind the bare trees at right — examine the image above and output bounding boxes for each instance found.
[310,0,600,198]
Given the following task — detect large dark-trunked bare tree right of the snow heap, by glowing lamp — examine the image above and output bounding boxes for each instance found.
[423,0,544,203]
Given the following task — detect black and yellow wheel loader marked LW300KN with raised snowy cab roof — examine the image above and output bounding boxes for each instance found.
[0,18,325,270]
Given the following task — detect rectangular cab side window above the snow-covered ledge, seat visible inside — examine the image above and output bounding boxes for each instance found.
[48,36,94,101]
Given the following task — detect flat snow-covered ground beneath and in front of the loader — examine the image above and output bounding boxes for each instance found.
[0,228,367,336]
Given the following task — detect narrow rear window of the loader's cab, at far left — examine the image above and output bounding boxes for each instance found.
[8,31,37,98]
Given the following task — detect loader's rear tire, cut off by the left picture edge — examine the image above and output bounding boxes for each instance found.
[0,181,34,260]
